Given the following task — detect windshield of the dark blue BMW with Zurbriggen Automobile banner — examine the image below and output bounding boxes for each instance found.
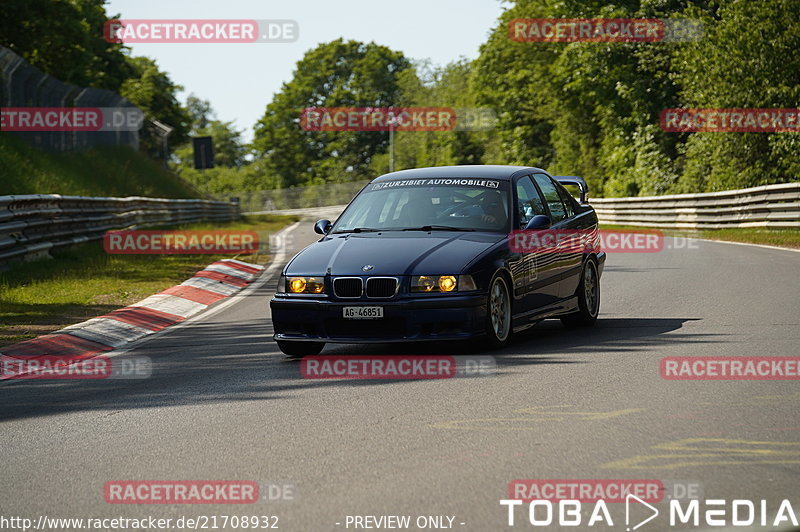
[332,178,509,233]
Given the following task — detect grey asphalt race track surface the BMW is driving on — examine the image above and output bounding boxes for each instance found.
[0,217,800,531]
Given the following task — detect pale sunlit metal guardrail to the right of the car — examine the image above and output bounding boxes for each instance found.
[590,182,800,229]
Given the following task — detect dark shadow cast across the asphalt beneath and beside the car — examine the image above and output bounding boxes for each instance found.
[0,318,712,420]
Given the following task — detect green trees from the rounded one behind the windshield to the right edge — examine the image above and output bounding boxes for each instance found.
[248,0,800,196]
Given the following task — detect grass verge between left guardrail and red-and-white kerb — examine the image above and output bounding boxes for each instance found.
[0,215,297,346]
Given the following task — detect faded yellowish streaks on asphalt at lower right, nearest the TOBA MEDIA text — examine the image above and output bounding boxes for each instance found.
[600,438,800,470]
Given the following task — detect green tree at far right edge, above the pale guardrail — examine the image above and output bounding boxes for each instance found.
[674,0,800,192]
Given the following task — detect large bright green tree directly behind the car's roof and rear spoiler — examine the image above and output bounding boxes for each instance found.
[475,0,732,196]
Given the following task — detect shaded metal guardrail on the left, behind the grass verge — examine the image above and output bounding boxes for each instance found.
[0,194,240,265]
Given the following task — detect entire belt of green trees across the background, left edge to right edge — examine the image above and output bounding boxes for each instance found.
[0,0,800,196]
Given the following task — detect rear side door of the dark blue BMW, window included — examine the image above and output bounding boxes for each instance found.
[532,173,582,298]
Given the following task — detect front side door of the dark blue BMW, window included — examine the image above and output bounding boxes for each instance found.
[515,176,559,311]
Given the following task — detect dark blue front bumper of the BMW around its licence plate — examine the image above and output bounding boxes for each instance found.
[270,294,486,344]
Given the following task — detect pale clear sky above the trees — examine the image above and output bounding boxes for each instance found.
[106,0,504,141]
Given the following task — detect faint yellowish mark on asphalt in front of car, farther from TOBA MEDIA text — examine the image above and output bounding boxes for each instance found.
[431,405,644,430]
